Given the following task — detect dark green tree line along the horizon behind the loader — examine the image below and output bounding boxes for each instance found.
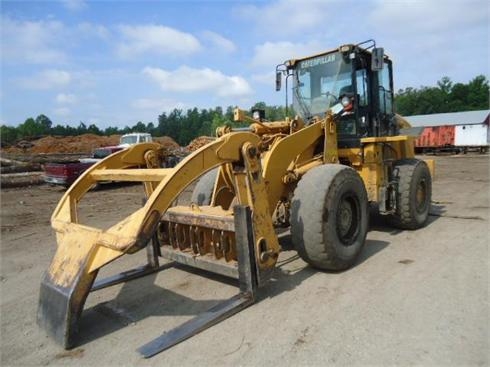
[0,75,490,146]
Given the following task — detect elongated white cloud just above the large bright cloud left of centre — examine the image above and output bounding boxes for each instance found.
[117,25,201,58]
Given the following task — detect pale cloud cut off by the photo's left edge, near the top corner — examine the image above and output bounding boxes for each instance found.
[0,16,66,64]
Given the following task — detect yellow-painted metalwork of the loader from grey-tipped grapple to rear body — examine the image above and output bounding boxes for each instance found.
[39,107,433,354]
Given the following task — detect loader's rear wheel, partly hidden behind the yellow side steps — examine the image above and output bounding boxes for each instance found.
[389,159,432,229]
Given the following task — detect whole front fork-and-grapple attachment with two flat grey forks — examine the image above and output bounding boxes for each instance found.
[38,132,279,357]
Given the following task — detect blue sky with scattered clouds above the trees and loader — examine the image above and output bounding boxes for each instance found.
[0,0,490,128]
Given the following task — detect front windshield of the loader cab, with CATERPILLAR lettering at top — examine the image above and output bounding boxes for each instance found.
[293,52,352,119]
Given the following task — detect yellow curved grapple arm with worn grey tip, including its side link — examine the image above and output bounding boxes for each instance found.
[38,132,279,354]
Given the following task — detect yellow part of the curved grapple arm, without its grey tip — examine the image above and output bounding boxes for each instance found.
[48,132,279,286]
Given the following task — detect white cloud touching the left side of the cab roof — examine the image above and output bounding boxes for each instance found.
[252,41,325,67]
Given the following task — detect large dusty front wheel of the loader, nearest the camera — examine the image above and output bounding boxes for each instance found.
[291,164,368,271]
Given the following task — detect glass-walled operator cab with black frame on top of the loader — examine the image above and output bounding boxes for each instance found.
[276,40,398,148]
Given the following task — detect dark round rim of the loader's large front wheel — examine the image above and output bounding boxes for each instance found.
[336,194,360,246]
